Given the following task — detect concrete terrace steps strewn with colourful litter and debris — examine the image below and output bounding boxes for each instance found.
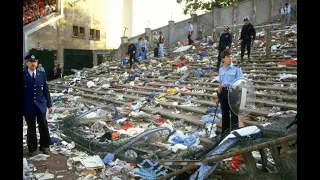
[23,21,297,180]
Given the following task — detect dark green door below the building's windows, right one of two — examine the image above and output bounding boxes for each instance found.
[63,49,93,75]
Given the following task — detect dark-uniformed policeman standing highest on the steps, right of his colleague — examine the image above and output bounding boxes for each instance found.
[239,17,256,62]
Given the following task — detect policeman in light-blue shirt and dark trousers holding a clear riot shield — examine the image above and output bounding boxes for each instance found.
[216,50,243,134]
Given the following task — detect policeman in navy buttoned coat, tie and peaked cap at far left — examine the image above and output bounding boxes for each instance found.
[23,55,52,156]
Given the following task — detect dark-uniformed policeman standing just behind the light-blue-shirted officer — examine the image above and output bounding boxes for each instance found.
[217,26,232,70]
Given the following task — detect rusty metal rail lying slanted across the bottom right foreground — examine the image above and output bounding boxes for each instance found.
[157,133,297,180]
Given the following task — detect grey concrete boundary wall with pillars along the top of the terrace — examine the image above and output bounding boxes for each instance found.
[129,0,297,46]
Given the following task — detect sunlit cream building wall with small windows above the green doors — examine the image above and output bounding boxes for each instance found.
[28,0,106,64]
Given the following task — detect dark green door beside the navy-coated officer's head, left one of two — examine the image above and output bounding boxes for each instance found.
[30,49,54,81]
